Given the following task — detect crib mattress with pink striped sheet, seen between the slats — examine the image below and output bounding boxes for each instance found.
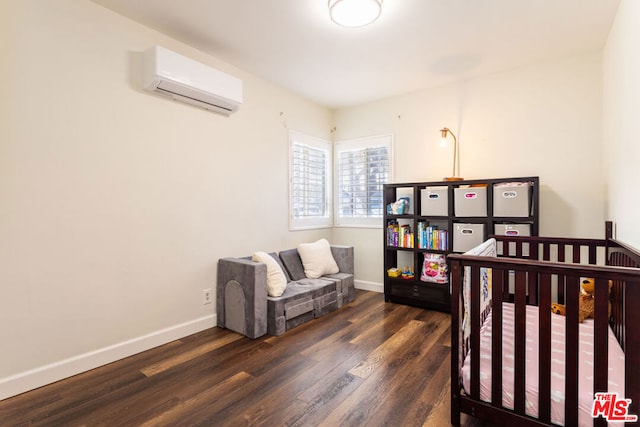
[462,303,624,425]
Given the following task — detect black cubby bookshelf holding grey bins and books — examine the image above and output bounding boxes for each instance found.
[383,177,540,312]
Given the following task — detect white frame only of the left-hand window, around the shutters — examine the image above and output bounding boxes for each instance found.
[289,130,333,231]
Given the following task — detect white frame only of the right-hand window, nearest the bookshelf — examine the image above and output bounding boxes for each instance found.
[333,134,394,228]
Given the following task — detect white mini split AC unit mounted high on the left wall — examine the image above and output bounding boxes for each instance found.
[142,46,242,115]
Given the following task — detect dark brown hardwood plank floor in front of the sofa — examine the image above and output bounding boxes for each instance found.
[0,291,490,427]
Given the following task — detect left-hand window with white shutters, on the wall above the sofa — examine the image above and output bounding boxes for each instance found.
[289,131,332,230]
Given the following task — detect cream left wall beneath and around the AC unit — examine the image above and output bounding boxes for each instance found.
[0,0,331,398]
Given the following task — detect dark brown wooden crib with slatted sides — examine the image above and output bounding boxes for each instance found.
[449,223,640,426]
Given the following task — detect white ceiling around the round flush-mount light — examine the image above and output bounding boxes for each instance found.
[93,0,619,108]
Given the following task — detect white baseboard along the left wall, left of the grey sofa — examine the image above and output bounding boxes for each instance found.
[0,314,217,400]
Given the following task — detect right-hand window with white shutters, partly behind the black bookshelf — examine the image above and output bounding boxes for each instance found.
[334,135,393,227]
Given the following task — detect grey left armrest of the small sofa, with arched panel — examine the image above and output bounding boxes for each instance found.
[216,258,267,338]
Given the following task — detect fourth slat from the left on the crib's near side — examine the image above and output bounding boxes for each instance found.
[538,273,551,424]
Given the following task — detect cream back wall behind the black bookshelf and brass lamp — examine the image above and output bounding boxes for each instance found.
[334,53,605,284]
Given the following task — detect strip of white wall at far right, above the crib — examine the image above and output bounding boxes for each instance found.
[603,0,640,248]
